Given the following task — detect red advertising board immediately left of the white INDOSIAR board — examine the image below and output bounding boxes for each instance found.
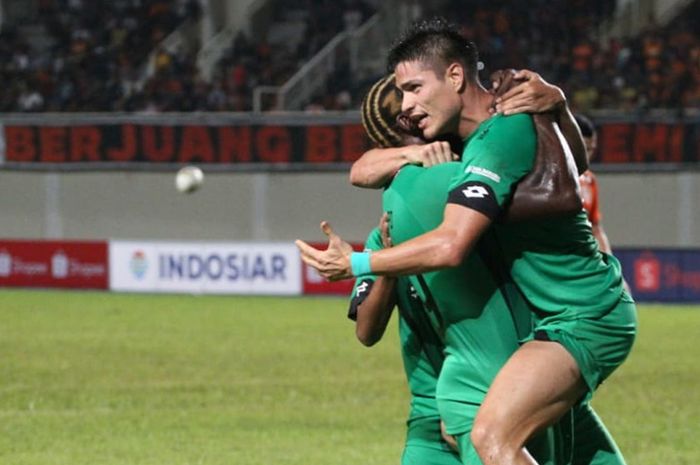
[0,240,109,289]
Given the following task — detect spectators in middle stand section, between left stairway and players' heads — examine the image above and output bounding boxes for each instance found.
[129,0,373,112]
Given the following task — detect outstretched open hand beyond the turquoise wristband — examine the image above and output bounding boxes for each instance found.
[294,221,352,281]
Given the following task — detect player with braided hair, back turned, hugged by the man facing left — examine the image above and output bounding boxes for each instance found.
[348,75,580,464]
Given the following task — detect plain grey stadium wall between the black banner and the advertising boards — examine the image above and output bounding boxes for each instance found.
[0,167,700,250]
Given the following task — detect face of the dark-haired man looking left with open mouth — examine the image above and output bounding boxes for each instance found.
[395,61,462,140]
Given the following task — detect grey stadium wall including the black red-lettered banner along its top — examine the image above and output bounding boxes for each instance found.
[0,112,700,248]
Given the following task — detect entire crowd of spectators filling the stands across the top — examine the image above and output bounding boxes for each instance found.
[0,0,700,112]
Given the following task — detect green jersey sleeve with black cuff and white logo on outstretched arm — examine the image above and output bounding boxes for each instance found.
[447,114,537,220]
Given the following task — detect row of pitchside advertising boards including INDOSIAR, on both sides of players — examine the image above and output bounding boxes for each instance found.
[0,240,700,303]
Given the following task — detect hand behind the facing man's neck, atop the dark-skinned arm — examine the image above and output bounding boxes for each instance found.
[495,70,566,115]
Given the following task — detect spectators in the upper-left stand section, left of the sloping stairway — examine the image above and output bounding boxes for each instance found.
[0,0,199,112]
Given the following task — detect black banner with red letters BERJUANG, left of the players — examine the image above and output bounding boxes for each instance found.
[4,122,371,164]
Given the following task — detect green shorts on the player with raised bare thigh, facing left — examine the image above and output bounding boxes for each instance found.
[527,297,637,400]
